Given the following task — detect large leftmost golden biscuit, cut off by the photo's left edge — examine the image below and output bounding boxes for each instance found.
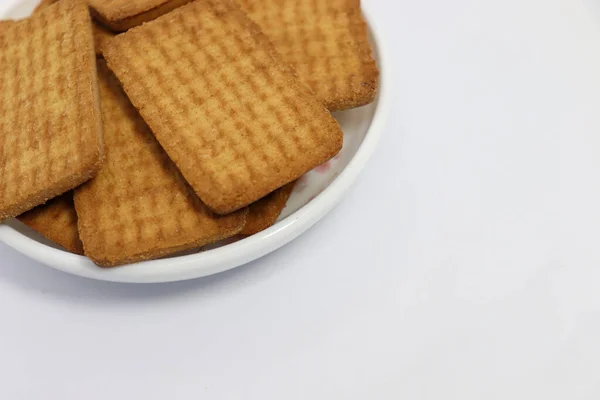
[0,0,102,222]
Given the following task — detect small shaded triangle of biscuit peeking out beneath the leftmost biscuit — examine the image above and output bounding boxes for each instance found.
[17,191,83,254]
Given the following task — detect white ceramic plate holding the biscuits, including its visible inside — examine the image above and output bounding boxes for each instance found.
[0,0,391,283]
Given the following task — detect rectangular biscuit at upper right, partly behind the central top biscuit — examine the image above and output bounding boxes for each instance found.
[238,0,379,111]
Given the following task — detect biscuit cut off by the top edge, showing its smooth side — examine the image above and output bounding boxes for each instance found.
[88,0,191,32]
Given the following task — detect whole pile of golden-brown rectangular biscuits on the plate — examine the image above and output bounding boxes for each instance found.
[0,0,379,267]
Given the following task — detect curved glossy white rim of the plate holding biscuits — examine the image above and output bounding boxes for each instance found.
[0,4,392,283]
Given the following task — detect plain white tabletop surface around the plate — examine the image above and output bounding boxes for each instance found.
[0,0,600,400]
